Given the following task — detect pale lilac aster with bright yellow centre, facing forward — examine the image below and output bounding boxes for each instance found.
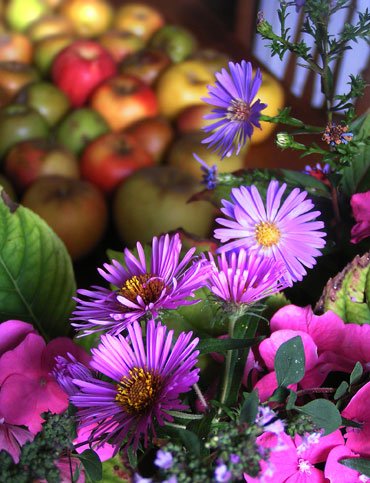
[215,180,326,285]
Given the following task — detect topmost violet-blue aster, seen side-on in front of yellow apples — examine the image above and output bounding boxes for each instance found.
[202,60,267,158]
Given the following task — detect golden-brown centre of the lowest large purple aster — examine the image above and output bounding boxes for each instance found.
[116,367,162,414]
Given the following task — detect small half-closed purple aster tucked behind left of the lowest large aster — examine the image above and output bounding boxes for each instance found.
[51,353,93,396]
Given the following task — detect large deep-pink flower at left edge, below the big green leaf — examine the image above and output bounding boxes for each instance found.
[0,321,89,434]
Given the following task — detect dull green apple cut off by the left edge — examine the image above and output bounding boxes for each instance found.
[0,104,49,157]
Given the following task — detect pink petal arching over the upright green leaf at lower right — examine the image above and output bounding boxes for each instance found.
[259,330,318,371]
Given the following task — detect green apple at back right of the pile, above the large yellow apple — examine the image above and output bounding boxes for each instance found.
[149,25,197,62]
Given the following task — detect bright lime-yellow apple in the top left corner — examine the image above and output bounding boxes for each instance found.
[5,0,49,31]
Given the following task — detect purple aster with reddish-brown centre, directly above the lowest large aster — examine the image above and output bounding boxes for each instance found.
[72,234,210,335]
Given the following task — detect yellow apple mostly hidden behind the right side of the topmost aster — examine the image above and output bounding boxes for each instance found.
[251,72,285,144]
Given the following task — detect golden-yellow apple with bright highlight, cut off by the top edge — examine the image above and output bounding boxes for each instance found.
[61,0,113,37]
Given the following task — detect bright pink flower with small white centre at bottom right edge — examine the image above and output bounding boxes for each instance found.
[244,430,344,483]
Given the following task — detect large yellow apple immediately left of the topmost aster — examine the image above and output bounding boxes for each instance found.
[155,60,214,119]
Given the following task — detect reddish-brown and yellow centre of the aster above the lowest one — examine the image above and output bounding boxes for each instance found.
[121,273,165,305]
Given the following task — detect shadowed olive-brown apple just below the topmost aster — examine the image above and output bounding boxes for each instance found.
[166,132,248,181]
